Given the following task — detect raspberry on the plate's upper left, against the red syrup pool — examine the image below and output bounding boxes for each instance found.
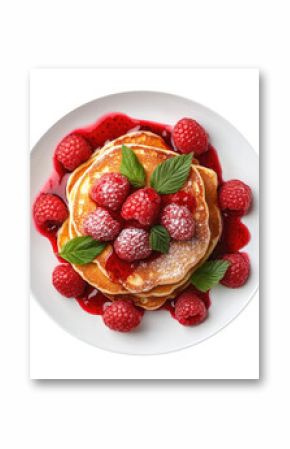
[55,134,92,171]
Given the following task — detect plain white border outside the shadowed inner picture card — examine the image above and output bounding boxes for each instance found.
[0,0,290,449]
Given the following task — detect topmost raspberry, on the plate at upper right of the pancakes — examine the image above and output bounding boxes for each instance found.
[173,118,208,154]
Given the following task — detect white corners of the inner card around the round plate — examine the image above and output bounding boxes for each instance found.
[30,69,259,379]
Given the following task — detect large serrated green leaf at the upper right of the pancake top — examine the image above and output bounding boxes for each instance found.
[150,153,192,194]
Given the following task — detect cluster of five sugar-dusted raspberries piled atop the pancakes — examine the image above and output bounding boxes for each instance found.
[83,173,195,262]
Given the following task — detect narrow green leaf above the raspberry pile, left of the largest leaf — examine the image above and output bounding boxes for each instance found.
[120,145,146,188]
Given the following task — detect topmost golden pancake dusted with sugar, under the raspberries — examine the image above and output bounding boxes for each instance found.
[67,132,210,293]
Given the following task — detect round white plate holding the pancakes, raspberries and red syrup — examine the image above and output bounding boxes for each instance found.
[31,92,259,354]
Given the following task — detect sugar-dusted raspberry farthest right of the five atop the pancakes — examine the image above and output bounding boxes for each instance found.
[161,203,195,240]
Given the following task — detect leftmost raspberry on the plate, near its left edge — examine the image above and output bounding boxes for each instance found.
[33,193,68,232]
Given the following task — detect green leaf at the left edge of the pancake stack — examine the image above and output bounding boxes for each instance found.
[59,236,106,265]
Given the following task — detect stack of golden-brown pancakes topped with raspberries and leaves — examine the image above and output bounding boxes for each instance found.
[58,131,222,310]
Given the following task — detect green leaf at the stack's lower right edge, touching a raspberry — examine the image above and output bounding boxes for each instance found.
[191,260,230,292]
